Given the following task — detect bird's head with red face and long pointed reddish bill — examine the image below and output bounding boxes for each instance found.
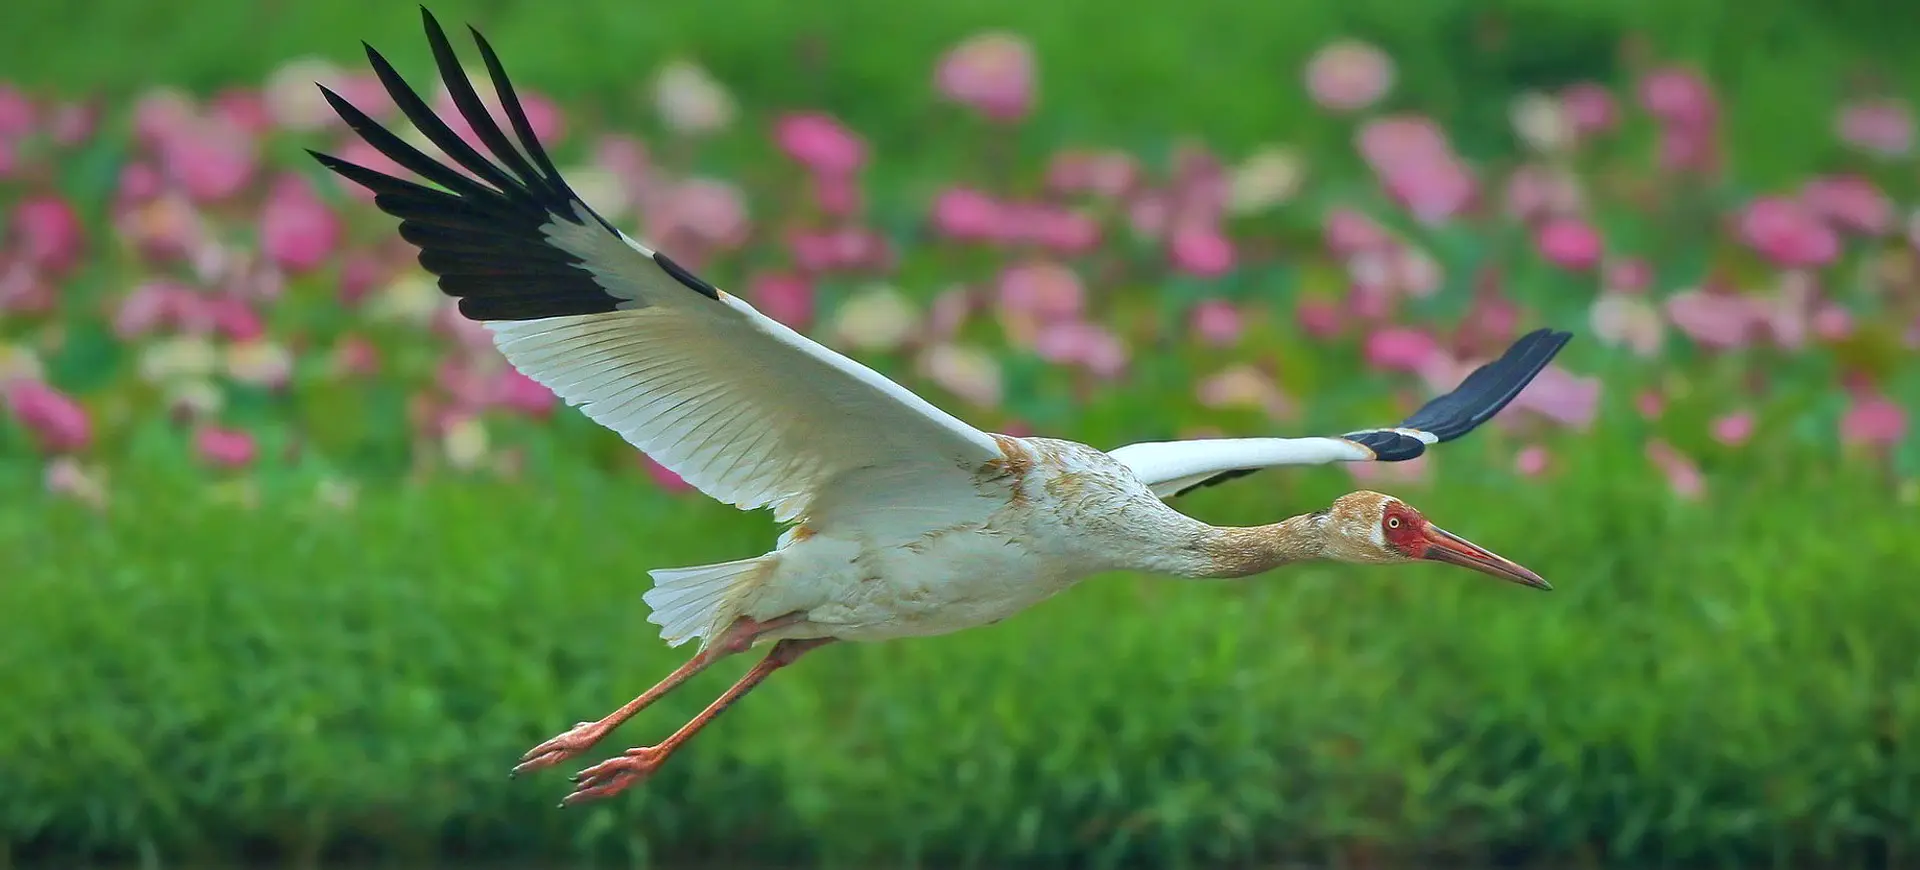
[1323,490,1551,590]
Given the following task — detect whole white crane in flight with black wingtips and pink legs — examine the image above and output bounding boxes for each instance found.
[313,8,1571,805]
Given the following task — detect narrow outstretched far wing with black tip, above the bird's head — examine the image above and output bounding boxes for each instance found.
[1110,328,1572,499]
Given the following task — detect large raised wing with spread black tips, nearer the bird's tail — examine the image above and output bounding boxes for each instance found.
[313,10,1002,520]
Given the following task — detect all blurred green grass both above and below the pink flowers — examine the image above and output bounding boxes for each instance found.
[0,0,1920,866]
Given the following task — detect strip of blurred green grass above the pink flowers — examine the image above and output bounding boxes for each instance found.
[15,0,1920,182]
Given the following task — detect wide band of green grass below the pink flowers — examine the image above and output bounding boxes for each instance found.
[0,414,1920,866]
